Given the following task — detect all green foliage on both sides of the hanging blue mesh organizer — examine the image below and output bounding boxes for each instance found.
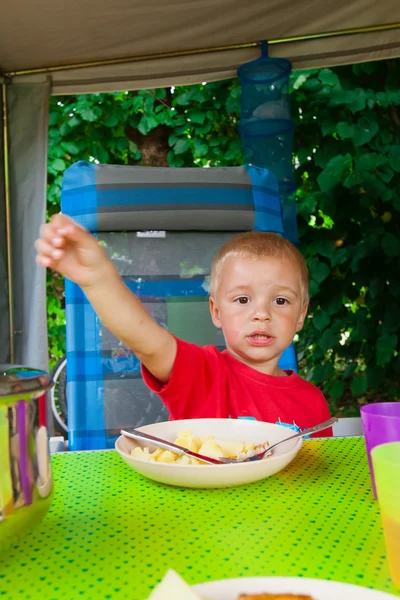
[48,61,400,414]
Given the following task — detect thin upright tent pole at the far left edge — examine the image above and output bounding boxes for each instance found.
[1,79,15,363]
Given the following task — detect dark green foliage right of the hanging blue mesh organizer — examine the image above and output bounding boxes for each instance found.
[292,61,400,414]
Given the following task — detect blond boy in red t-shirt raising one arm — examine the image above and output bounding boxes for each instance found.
[35,214,330,435]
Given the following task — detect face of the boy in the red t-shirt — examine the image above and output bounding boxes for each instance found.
[210,257,307,375]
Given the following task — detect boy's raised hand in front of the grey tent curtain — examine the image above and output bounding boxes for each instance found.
[35,214,112,289]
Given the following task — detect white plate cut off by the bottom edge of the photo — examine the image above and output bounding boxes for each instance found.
[193,577,399,600]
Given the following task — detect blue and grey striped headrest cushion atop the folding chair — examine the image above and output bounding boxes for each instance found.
[61,161,283,233]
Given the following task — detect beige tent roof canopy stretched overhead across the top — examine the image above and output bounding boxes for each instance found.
[0,0,400,94]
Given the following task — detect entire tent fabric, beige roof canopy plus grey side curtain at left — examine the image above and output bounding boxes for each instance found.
[0,0,400,376]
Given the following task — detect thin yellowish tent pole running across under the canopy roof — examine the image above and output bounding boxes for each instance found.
[6,23,400,77]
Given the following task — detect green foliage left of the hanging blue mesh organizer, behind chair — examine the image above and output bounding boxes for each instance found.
[47,80,243,365]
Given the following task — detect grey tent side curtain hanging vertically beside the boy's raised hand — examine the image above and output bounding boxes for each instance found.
[7,83,50,370]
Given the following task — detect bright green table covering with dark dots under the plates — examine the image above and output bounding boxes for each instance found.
[0,438,400,600]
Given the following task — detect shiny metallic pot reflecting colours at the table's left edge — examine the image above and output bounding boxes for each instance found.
[0,365,53,554]
